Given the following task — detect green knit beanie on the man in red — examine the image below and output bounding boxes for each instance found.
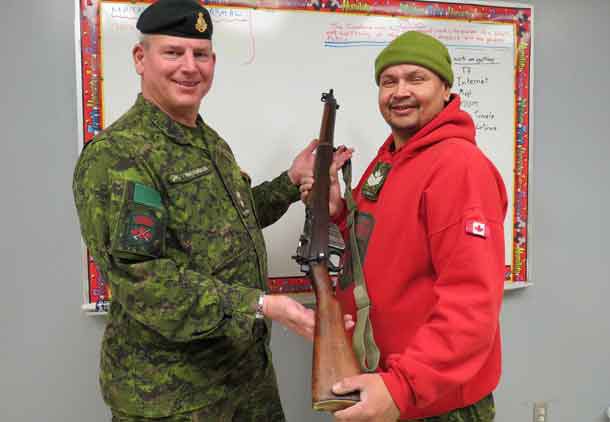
[375,31,453,86]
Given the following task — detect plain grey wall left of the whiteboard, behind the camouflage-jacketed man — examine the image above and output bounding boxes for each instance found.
[0,0,107,422]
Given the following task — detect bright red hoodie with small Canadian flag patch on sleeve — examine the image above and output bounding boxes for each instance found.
[337,95,507,419]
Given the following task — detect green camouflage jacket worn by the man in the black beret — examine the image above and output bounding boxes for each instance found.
[73,96,299,420]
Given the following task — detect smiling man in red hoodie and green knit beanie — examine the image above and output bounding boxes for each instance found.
[301,31,507,422]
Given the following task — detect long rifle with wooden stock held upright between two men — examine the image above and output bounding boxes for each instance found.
[295,89,360,412]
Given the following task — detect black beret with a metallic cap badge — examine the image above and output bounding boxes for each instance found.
[136,0,212,40]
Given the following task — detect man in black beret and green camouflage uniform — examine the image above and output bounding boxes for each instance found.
[73,0,350,422]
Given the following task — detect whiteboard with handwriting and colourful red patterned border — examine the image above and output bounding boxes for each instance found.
[77,0,531,310]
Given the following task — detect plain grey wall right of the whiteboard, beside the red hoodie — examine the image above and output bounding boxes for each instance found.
[490,0,610,422]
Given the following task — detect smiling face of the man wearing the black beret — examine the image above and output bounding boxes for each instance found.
[133,35,216,125]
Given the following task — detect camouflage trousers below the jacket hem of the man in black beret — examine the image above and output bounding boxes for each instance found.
[112,365,286,422]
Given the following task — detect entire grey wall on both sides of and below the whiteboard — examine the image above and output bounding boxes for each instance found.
[0,0,610,422]
